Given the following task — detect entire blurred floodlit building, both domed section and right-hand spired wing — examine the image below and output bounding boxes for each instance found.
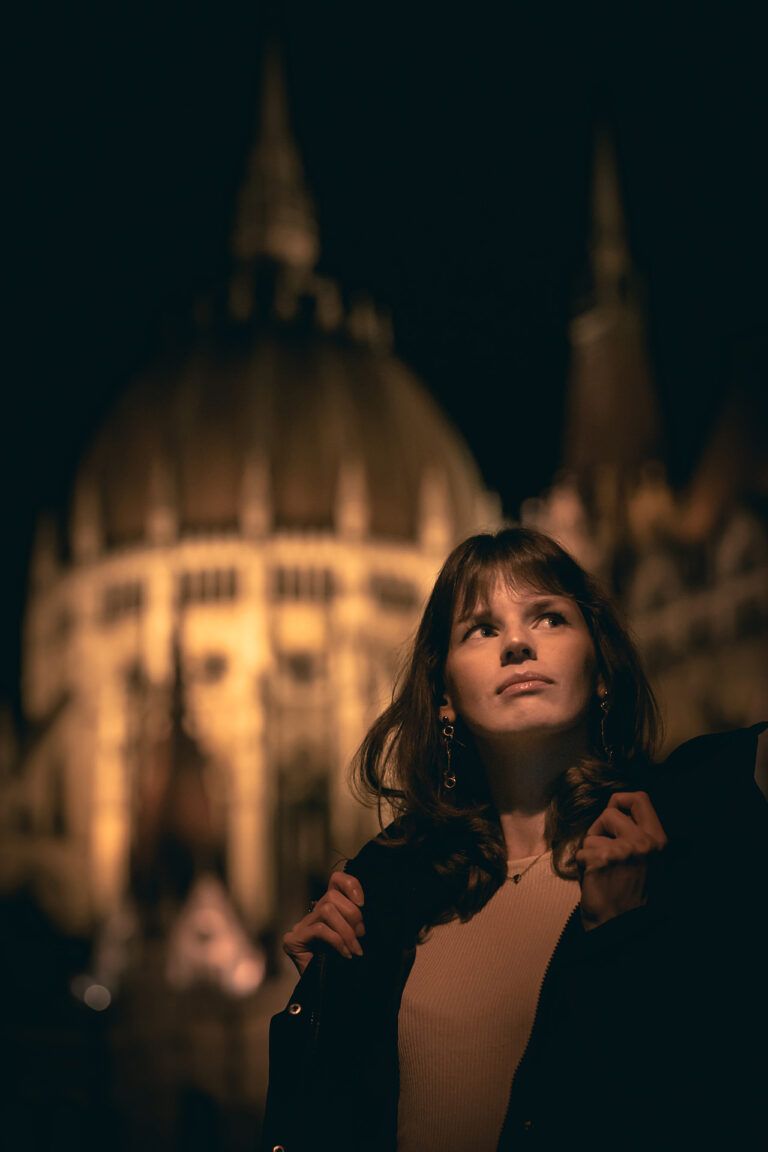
[0,55,768,958]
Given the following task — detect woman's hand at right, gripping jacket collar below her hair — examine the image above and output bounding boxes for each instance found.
[576,793,667,932]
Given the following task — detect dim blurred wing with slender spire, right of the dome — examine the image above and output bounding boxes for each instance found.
[522,135,768,749]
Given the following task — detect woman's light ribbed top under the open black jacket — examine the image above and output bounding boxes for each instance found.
[397,852,579,1152]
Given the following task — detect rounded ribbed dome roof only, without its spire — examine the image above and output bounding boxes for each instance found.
[74,317,490,547]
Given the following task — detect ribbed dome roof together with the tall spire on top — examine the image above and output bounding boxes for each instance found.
[73,42,494,555]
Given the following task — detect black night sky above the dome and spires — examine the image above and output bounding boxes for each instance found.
[0,0,768,696]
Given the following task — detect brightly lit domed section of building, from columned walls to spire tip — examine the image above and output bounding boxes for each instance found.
[0,55,497,932]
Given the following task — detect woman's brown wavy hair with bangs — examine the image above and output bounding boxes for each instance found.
[352,528,660,919]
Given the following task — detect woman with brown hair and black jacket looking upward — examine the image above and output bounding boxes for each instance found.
[263,528,766,1152]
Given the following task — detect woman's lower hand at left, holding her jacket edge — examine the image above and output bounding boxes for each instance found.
[282,872,365,976]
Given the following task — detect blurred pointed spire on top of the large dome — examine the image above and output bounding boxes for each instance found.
[231,39,319,273]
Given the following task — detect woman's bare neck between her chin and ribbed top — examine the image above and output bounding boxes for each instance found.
[478,730,587,859]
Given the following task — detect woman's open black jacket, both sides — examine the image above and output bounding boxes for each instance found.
[261,725,768,1152]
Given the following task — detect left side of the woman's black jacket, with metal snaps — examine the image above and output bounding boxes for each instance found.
[260,841,423,1152]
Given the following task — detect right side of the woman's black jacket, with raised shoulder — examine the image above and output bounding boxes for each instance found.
[500,728,768,1149]
